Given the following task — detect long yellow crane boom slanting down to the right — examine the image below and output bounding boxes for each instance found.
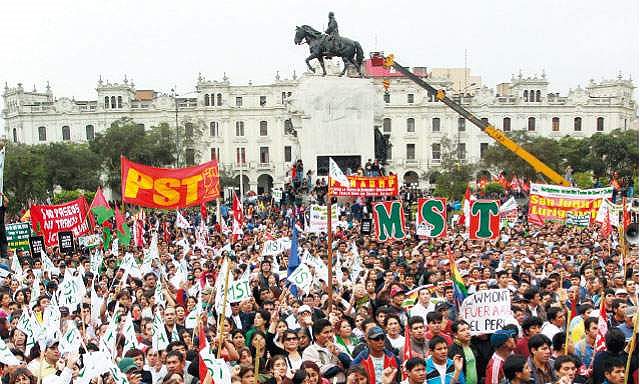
[384,55,571,187]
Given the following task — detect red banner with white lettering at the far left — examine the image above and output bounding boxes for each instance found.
[31,197,90,247]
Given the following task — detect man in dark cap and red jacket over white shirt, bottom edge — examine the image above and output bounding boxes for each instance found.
[351,326,400,384]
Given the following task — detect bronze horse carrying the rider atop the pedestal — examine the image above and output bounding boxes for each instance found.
[293,25,364,77]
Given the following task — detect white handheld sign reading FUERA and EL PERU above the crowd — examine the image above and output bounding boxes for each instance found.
[460,289,517,336]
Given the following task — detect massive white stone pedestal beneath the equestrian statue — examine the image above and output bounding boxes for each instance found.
[290,75,383,176]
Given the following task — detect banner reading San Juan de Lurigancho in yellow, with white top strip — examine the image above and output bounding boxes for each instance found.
[529,184,613,225]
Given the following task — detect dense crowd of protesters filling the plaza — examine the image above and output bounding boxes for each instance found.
[0,179,639,384]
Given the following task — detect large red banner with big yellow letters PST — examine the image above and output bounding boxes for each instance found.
[120,156,220,209]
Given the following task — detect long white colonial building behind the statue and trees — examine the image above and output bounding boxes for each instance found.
[2,61,637,192]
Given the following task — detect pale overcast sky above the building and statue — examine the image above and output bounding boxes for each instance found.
[0,0,639,99]
